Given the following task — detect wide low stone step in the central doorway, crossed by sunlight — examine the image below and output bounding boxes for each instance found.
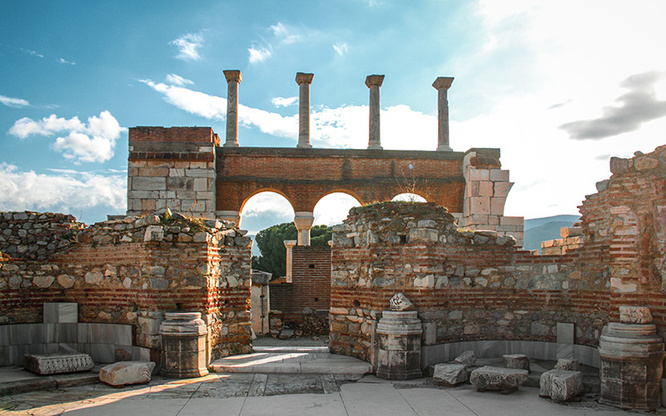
[210,347,372,375]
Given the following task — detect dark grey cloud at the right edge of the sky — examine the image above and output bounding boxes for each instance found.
[560,71,666,140]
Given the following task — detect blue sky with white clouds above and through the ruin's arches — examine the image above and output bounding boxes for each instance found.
[0,0,666,239]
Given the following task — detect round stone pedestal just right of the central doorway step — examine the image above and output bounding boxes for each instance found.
[376,311,423,380]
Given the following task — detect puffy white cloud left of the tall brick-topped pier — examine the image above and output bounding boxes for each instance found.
[9,111,127,163]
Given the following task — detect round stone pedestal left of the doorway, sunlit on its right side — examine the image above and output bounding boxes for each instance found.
[160,312,208,378]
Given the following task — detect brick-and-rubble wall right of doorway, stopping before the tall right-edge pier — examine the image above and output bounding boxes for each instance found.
[330,202,609,360]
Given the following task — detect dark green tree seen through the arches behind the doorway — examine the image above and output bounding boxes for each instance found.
[252,222,333,278]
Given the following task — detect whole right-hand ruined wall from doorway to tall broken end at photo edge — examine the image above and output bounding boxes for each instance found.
[330,146,666,366]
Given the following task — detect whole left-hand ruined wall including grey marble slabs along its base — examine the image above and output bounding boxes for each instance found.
[0,212,251,365]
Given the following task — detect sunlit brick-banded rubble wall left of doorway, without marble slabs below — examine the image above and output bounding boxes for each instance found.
[0,213,251,364]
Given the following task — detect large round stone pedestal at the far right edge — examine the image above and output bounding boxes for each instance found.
[599,322,664,410]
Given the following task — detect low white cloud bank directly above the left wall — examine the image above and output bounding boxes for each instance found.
[0,162,127,212]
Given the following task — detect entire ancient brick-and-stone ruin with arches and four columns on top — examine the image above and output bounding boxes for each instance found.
[0,71,666,409]
